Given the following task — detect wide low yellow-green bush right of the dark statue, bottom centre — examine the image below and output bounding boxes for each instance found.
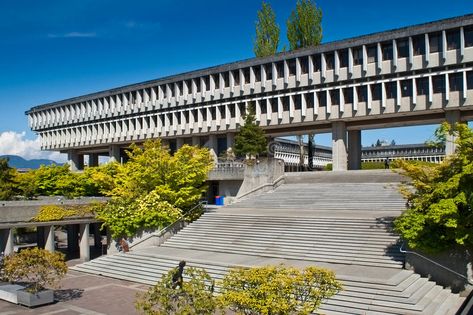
[219,265,342,315]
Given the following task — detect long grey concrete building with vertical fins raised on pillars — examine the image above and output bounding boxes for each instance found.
[26,15,473,171]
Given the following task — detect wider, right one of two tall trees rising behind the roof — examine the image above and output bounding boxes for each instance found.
[286,0,322,50]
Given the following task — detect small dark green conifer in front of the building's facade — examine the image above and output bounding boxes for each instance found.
[234,103,267,157]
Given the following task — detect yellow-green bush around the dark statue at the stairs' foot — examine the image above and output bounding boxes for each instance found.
[135,267,217,315]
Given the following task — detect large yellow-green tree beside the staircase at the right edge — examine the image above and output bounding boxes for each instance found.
[395,124,473,252]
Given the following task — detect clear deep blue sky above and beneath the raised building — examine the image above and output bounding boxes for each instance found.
[0,0,473,159]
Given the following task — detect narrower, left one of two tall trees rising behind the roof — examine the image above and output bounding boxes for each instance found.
[253,1,279,57]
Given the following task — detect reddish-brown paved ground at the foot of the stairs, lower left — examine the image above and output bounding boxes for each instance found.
[0,262,148,315]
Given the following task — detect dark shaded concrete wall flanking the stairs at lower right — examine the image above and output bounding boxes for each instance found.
[406,247,473,296]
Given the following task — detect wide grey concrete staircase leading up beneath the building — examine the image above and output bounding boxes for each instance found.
[73,171,463,315]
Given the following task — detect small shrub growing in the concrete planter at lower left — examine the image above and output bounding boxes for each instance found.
[4,247,67,293]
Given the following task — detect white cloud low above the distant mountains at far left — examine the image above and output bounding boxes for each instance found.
[0,131,67,163]
